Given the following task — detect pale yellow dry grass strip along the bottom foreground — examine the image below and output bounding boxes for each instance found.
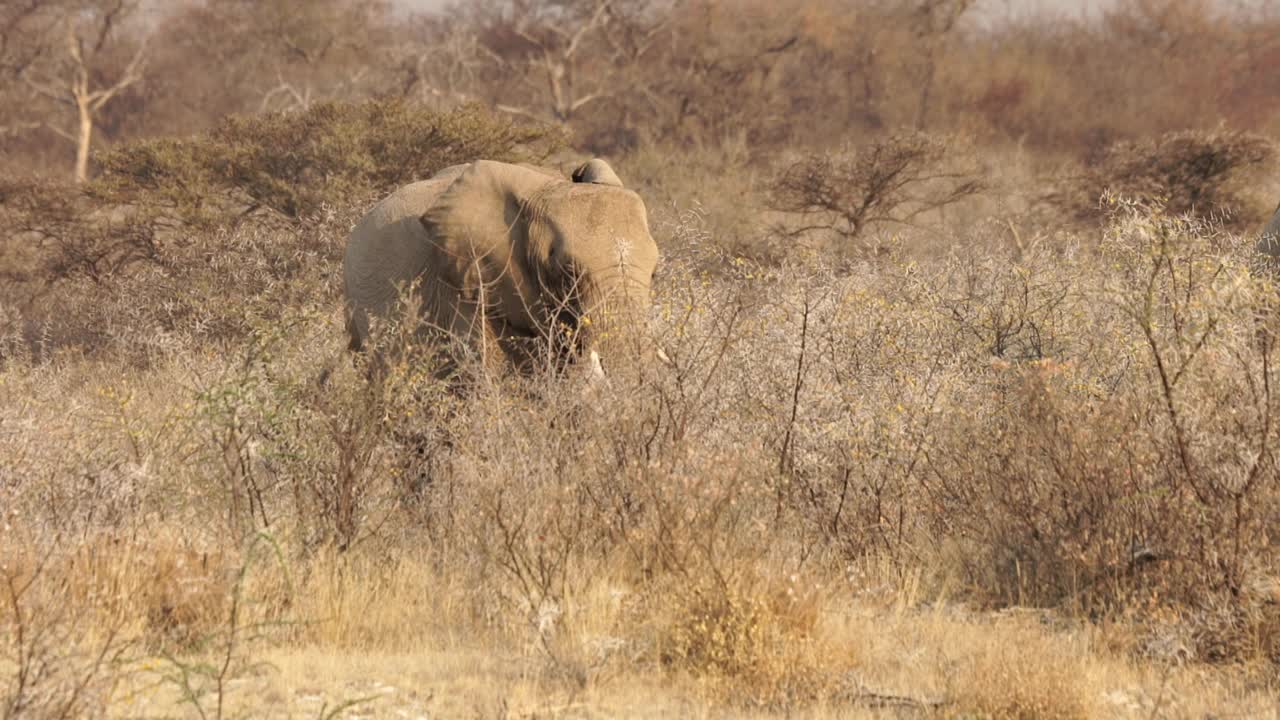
[15,540,1275,719]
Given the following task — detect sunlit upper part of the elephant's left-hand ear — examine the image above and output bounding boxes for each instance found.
[420,160,564,254]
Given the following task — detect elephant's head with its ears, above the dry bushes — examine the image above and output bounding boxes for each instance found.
[421,160,658,372]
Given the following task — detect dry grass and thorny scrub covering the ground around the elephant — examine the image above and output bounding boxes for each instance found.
[0,166,1280,717]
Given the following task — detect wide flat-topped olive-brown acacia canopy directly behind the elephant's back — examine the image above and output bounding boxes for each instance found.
[93,100,563,224]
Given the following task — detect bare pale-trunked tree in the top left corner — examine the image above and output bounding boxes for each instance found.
[19,0,147,182]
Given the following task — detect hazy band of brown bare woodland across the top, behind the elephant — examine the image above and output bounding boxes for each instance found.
[0,0,1280,179]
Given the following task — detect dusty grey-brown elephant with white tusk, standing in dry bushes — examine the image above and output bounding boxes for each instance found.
[343,159,659,375]
